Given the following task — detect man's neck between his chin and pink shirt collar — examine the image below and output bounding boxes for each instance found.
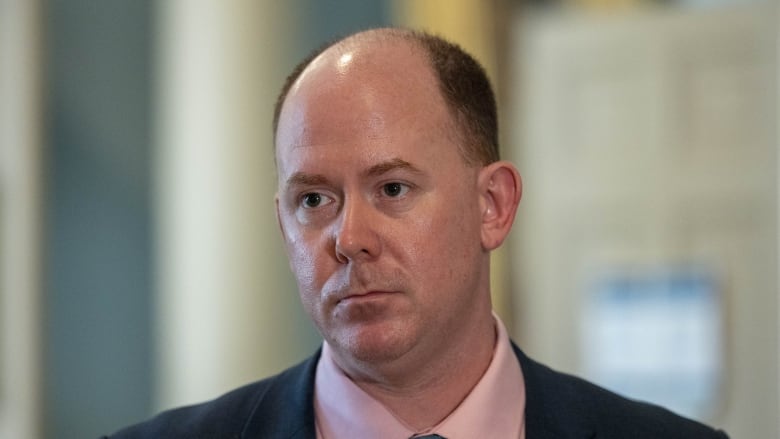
[338,314,496,431]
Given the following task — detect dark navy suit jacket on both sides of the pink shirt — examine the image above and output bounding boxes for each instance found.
[106,345,726,439]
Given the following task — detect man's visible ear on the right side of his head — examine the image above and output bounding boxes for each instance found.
[477,161,523,251]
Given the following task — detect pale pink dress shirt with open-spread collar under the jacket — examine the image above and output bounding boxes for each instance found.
[314,314,525,439]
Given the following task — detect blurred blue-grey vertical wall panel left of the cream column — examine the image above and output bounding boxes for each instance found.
[44,0,152,438]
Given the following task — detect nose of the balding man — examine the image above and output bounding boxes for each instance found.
[334,198,382,264]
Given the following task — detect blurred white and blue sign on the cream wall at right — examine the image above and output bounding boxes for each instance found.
[582,267,724,418]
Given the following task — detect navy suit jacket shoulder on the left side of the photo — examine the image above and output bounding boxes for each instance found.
[108,354,319,439]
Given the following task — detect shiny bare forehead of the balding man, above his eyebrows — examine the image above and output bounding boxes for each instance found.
[275,41,452,165]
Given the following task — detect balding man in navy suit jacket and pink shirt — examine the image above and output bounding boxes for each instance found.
[106,29,726,439]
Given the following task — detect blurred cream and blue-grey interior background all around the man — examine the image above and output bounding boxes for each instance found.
[0,0,780,439]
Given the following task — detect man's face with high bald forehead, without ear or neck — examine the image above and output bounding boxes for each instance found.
[276,41,489,367]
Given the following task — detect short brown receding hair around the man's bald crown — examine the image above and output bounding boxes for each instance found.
[273,28,499,165]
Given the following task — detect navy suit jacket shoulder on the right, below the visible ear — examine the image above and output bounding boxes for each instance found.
[515,348,727,439]
